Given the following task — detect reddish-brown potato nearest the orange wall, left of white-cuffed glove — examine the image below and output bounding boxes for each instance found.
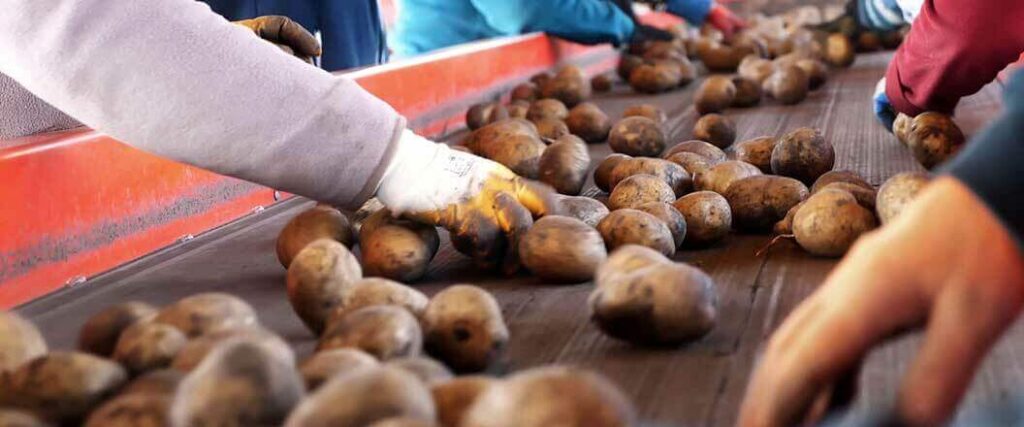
[276,205,355,268]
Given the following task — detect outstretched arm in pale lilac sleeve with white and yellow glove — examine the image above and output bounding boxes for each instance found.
[0,0,554,270]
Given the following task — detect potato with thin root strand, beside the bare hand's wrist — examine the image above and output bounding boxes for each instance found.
[793,189,879,257]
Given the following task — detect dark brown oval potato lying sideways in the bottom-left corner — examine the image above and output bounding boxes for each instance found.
[0,351,128,425]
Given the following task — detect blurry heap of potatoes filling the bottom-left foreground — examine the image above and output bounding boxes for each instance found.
[0,282,637,427]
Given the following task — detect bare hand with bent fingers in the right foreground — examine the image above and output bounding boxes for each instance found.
[737,176,1024,427]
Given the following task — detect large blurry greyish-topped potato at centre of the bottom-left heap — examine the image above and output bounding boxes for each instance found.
[171,340,305,427]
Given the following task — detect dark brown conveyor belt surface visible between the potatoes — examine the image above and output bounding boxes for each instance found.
[19,53,1007,426]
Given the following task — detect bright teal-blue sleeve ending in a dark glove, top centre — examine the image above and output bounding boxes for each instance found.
[471,0,634,44]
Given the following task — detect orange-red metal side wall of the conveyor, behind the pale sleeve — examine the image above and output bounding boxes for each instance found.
[0,11,688,308]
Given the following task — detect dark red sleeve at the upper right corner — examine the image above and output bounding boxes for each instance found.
[886,0,1024,116]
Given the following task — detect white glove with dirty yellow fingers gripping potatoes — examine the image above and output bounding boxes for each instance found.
[377,130,558,273]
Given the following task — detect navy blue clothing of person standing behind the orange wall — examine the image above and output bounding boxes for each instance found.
[202,0,387,71]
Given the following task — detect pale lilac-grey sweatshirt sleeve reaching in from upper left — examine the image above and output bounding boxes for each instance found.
[0,0,406,206]
